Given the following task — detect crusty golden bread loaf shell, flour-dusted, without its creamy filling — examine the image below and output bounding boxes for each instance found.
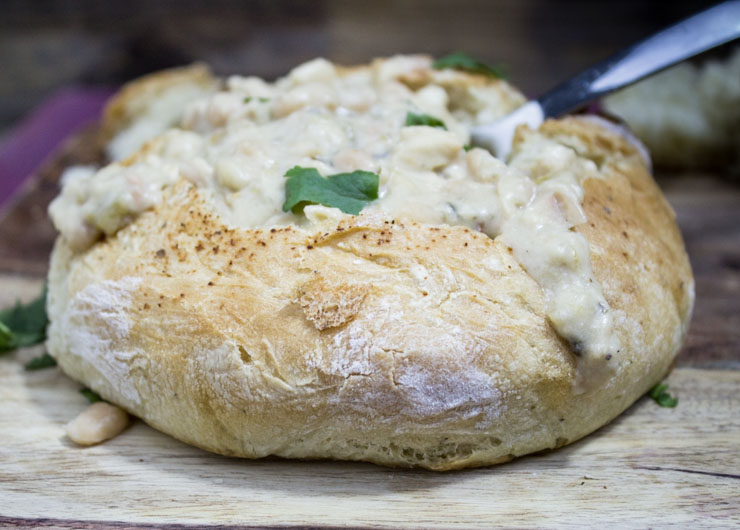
[48,55,693,470]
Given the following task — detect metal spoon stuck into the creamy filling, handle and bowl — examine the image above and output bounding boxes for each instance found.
[471,0,740,158]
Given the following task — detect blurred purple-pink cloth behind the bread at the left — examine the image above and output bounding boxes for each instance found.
[0,87,113,205]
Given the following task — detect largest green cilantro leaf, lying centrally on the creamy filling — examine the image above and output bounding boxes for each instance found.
[283,166,379,215]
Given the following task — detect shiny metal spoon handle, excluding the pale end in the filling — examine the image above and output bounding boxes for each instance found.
[537,0,740,117]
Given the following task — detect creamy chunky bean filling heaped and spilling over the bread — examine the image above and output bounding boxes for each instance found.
[50,56,619,364]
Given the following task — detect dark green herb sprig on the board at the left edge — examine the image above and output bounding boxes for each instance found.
[0,288,48,353]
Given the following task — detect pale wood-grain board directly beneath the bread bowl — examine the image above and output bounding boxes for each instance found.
[0,352,740,528]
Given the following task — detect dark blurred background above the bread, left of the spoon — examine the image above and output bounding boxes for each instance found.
[0,0,724,135]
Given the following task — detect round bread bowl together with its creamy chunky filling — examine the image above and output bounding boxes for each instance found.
[47,56,694,470]
